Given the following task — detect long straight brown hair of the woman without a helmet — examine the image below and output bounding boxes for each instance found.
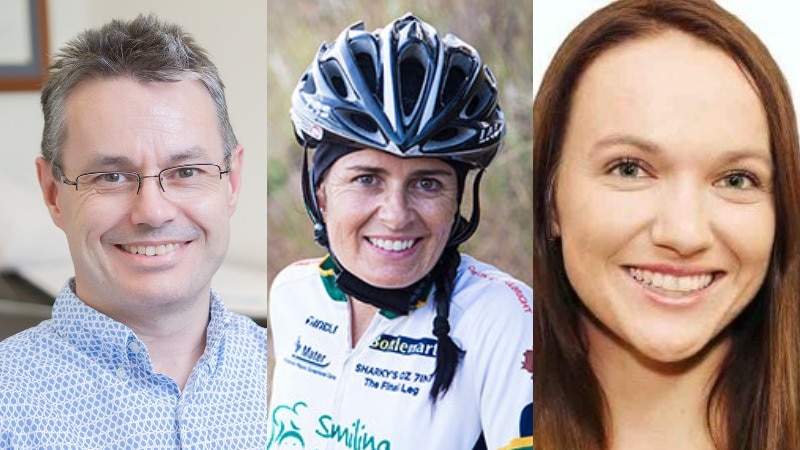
[533,0,800,450]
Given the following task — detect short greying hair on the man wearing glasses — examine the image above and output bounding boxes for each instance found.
[41,15,237,174]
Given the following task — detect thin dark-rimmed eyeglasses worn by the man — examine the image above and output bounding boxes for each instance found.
[58,164,231,200]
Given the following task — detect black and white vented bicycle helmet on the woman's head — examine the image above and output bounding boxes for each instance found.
[291,14,505,168]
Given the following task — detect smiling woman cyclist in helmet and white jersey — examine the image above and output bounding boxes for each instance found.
[268,15,533,449]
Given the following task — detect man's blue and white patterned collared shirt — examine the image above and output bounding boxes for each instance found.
[0,283,267,450]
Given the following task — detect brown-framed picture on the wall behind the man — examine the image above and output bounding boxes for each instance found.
[0,0,48,91]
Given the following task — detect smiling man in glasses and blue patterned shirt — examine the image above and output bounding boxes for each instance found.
[0,16,267,449]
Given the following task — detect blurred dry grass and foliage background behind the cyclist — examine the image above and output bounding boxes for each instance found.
[266,0,533,285]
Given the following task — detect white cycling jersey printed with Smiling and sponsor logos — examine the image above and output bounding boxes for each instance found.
[267,255,533,450]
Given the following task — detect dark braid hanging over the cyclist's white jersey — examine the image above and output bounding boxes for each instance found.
[431,246,464,403]
